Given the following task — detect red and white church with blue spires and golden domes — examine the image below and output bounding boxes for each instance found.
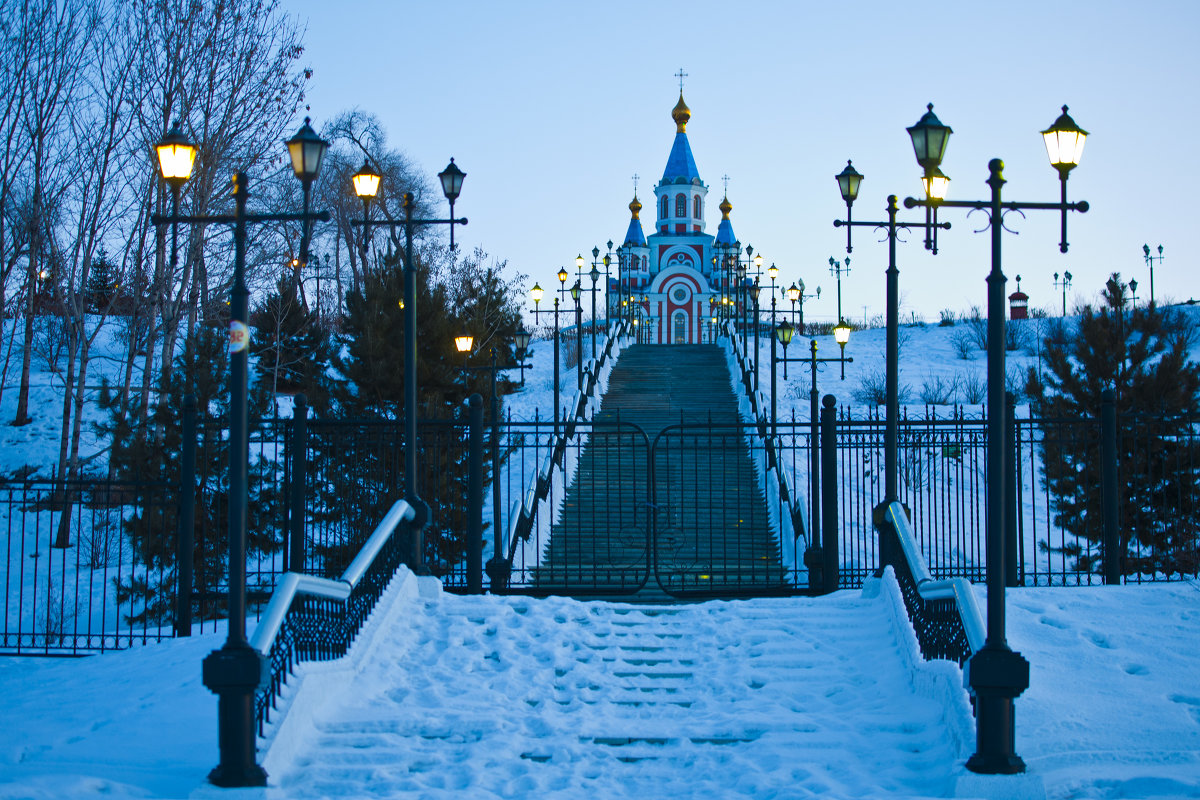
[608,89,750,344]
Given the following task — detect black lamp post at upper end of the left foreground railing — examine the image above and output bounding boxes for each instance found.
[350,158,467,573]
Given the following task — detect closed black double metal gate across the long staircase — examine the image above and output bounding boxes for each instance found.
[508,422,806,600]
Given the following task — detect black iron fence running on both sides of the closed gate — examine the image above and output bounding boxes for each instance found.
[0,391,1200,655]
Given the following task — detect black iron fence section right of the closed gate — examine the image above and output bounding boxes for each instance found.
[778,408,1200,587]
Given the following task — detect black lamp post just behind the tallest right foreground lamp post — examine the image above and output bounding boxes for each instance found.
[830,161,950,506]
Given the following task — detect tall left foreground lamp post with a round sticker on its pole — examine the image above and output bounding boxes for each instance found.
[151,119,329,787]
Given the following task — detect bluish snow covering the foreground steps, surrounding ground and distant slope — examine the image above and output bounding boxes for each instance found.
[0,316,1200,800]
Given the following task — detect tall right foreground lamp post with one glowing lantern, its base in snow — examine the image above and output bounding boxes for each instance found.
[905,104,1088,774]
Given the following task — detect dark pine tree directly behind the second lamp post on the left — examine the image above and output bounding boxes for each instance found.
[318,252,520,573]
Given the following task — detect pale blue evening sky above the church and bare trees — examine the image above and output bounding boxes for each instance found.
[283,0,1200,320]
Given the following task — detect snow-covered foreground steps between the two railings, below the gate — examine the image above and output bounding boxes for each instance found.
[266,578,964,800]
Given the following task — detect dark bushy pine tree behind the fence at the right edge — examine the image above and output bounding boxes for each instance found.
[1027,273,1200,575]
